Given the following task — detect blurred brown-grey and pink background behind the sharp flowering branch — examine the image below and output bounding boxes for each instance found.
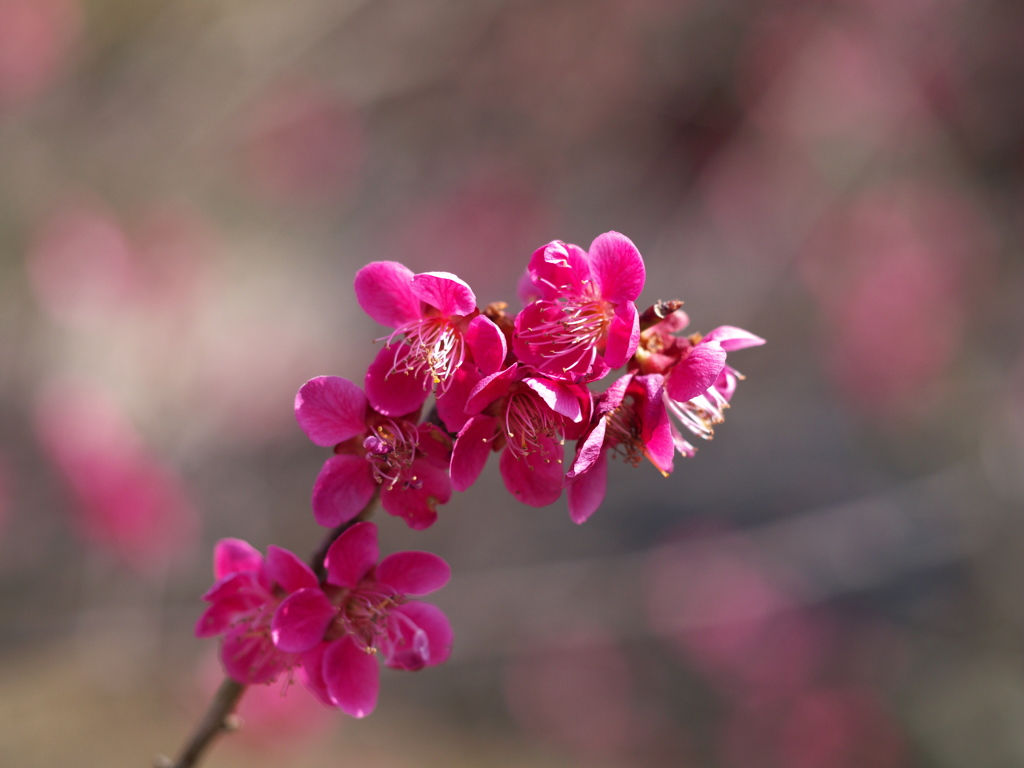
[0,0,1024,768]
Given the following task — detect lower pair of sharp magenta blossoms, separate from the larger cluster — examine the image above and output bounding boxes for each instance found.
[196,522,452,717]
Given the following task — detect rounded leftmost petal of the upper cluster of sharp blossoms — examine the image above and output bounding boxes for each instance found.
[295,376,367,447]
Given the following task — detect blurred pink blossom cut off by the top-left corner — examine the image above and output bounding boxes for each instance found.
[0,0,82,110]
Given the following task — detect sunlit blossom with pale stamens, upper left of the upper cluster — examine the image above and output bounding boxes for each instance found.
[355,261,504,416]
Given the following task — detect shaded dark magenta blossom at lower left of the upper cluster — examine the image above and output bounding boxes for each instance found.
[295,376,452,529]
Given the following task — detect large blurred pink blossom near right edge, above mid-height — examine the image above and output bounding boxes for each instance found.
[800,184,992,418]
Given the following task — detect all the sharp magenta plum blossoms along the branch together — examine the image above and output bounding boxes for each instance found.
[197,232,764,717]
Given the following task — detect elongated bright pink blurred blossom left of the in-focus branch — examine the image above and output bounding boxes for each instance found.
[35,381,198,573]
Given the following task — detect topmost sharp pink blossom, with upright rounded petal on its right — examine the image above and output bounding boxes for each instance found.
[513,232,646,381]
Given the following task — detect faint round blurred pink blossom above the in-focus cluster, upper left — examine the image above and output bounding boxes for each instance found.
[244,78,364,204]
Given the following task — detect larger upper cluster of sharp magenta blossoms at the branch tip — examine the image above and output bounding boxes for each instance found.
[307,232,764,528]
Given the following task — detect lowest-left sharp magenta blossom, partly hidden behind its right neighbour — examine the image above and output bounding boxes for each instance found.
[196,539,317,685]
